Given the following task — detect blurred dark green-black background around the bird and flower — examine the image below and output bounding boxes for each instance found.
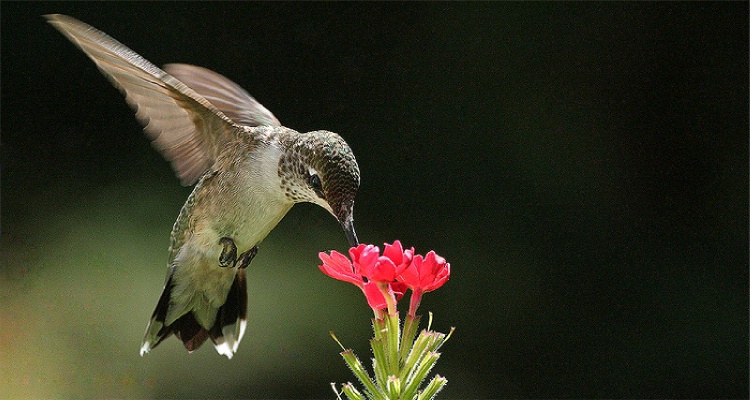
[0,2,748,398]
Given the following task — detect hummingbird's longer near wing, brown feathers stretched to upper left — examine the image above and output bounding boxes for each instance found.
[45,14,244,185]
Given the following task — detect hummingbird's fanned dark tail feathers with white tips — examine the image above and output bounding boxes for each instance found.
[141,269,247,359]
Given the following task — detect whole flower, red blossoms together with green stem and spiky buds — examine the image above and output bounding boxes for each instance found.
[319,240,453,400]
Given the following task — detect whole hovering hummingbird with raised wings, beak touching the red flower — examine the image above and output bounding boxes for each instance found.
[45,14,360,359]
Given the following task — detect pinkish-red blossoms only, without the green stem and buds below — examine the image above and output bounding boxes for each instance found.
[318,240,450,318]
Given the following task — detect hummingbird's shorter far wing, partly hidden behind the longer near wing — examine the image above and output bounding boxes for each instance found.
[164,64,281,126]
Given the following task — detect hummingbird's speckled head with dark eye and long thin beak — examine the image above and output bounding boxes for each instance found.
[279,131,359,247]
